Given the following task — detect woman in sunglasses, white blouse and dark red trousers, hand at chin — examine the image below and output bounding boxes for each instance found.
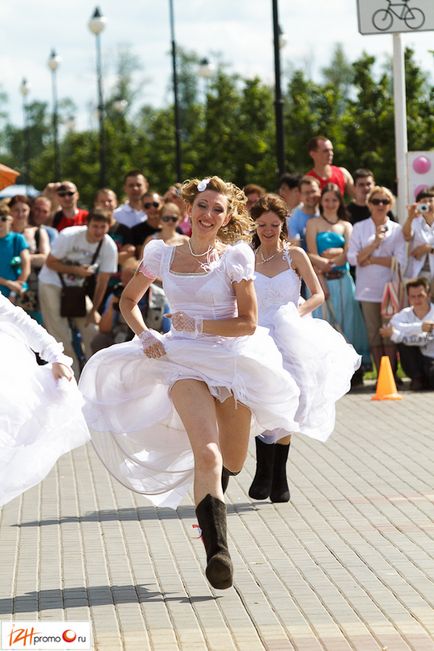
[348,185,405,374]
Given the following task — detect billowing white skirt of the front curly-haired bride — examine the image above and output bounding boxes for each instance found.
[79,328,299,508]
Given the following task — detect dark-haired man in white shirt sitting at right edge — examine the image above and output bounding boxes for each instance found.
[380,278,434,391]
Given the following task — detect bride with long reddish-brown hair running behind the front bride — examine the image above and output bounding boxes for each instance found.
[249,194,361,502]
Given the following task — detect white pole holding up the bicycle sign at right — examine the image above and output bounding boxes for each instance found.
[393,33,408,224]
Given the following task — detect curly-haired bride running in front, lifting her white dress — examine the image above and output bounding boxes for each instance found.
[80,176,299,589]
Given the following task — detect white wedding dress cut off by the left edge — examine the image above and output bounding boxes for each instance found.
[0,294,89,506]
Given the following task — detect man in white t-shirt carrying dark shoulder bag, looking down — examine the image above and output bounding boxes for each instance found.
[39,213,118,377]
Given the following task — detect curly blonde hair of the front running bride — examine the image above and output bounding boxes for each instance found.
[181,176,253,244]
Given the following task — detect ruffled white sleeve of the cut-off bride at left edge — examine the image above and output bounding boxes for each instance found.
[0,297,72,366]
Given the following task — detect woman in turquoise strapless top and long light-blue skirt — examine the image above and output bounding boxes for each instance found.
[306,183,370,365]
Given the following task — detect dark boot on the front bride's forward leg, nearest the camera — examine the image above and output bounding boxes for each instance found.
[196,494,233,590]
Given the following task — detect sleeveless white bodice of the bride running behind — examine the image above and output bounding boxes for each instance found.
[255,255,301,326]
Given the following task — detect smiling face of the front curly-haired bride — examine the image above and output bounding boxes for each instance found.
[190,190,230,236]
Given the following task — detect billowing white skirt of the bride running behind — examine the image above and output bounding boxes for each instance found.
[261,303,361,443]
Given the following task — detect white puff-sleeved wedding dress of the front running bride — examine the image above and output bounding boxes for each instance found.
[79,240,299,508]
